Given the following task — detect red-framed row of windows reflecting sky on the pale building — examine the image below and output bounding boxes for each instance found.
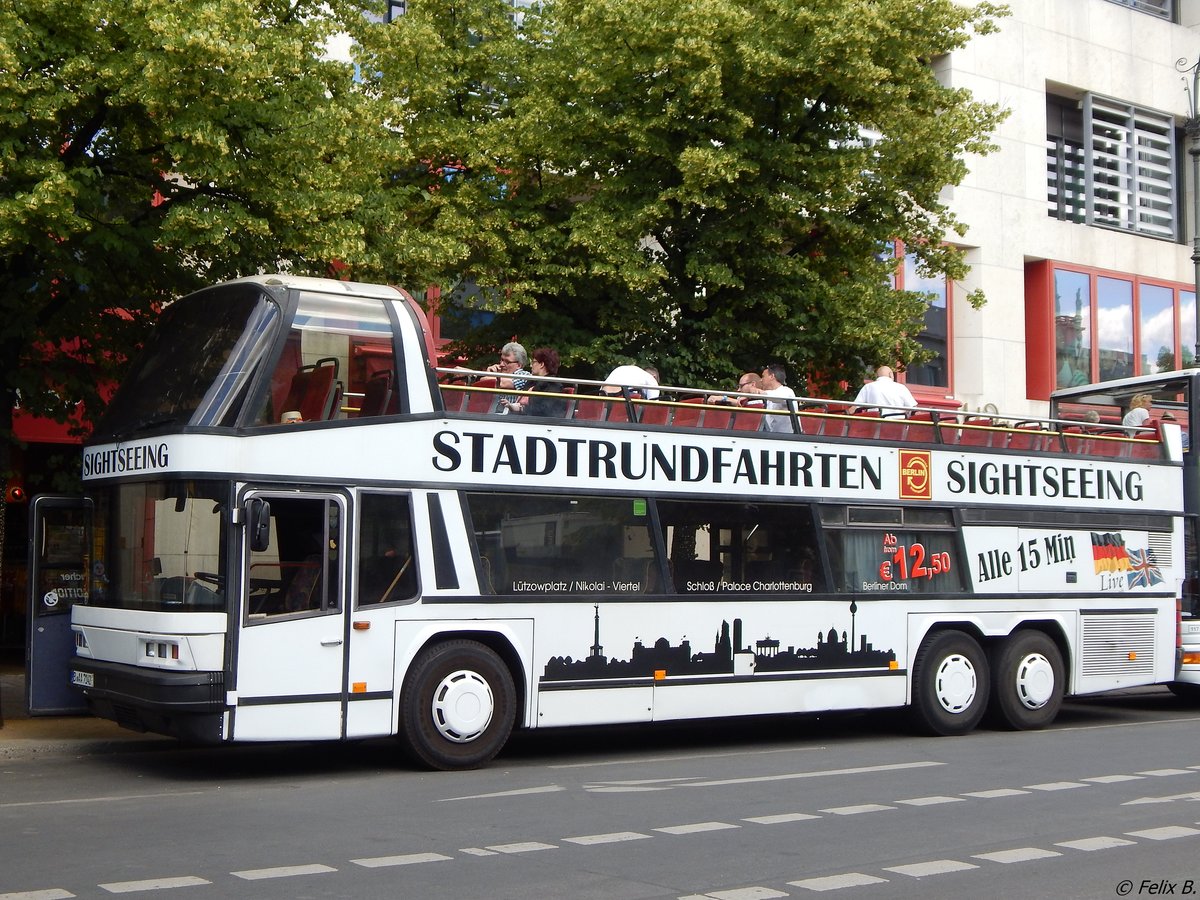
[1025,262,1195,400]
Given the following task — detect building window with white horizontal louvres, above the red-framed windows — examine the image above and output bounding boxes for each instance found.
[1046,94,1177,240]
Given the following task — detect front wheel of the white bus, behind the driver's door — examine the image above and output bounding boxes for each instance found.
[400,641,516,770]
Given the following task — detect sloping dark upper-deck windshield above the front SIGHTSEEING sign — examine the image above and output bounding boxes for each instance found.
[95,283,281,440]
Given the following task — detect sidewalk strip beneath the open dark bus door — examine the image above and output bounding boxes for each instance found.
[0,664,176,761]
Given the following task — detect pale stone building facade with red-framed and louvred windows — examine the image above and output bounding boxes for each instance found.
[926,0,1200,414]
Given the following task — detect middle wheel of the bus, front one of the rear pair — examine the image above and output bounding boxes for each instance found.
[912,631,990,734]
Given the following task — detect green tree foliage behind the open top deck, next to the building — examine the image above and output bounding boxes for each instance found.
[364,0,1002,386]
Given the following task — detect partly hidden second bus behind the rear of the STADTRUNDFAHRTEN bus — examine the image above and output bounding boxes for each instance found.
[1050,368,1200,701]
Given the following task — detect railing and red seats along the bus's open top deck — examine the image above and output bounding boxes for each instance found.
[437,368,1169,461]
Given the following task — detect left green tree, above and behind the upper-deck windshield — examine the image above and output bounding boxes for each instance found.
[0,0,378,578]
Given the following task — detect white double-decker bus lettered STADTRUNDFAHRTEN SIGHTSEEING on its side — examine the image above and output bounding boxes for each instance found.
[71,275,1184,769]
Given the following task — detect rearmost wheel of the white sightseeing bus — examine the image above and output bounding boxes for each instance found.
[989,630,1067,731]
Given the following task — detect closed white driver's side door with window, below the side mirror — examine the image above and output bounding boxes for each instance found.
[233,491,347,740]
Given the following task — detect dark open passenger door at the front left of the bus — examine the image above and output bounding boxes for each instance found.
[25,496,91,715]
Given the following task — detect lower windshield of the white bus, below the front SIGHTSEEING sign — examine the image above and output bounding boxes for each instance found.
[88,481,228,612]
